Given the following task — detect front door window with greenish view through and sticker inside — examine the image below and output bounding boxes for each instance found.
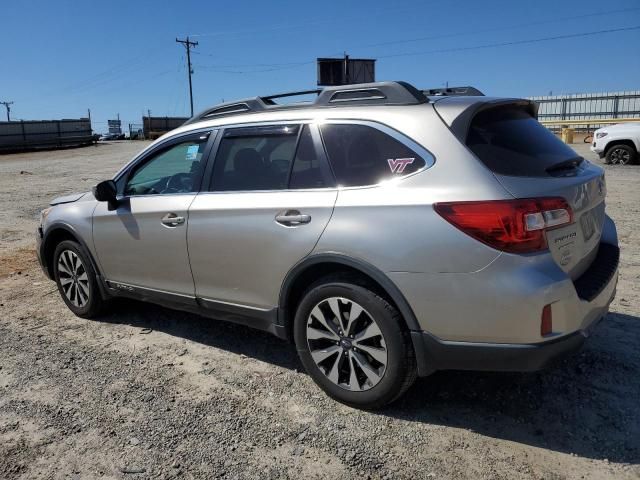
[124,135,208,196]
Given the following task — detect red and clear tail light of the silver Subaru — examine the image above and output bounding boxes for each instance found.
[433,197,573,253]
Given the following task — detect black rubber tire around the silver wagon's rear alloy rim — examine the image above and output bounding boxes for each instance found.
[294,276,416,410]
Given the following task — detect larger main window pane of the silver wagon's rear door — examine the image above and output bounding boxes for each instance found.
[212,125,300,191]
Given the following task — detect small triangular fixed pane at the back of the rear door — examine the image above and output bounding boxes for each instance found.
[289,125,334,189]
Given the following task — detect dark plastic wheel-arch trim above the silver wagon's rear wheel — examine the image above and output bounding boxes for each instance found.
[277,253,421,338]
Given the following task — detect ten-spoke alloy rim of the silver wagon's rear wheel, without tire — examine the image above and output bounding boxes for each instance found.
[307,297,387,391]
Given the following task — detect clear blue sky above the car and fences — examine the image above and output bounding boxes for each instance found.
[0,0,640,132]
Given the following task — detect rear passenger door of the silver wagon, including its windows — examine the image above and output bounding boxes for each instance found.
[188,124,337,316]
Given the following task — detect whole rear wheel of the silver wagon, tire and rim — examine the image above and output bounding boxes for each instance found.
[294,277,416,409]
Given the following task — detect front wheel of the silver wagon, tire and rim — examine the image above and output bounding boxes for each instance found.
[53,240,107,318]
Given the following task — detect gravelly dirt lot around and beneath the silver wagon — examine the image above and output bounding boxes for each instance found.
[0,142,640,479]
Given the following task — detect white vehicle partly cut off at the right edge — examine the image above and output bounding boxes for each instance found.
[591,122,640,165]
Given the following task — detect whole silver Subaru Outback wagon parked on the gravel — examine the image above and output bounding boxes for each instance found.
[37,82,619,408]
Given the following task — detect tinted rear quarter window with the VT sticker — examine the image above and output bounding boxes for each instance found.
[321,124,425,186]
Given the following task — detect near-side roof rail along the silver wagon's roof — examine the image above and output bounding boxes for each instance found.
[185,82,429,125]
